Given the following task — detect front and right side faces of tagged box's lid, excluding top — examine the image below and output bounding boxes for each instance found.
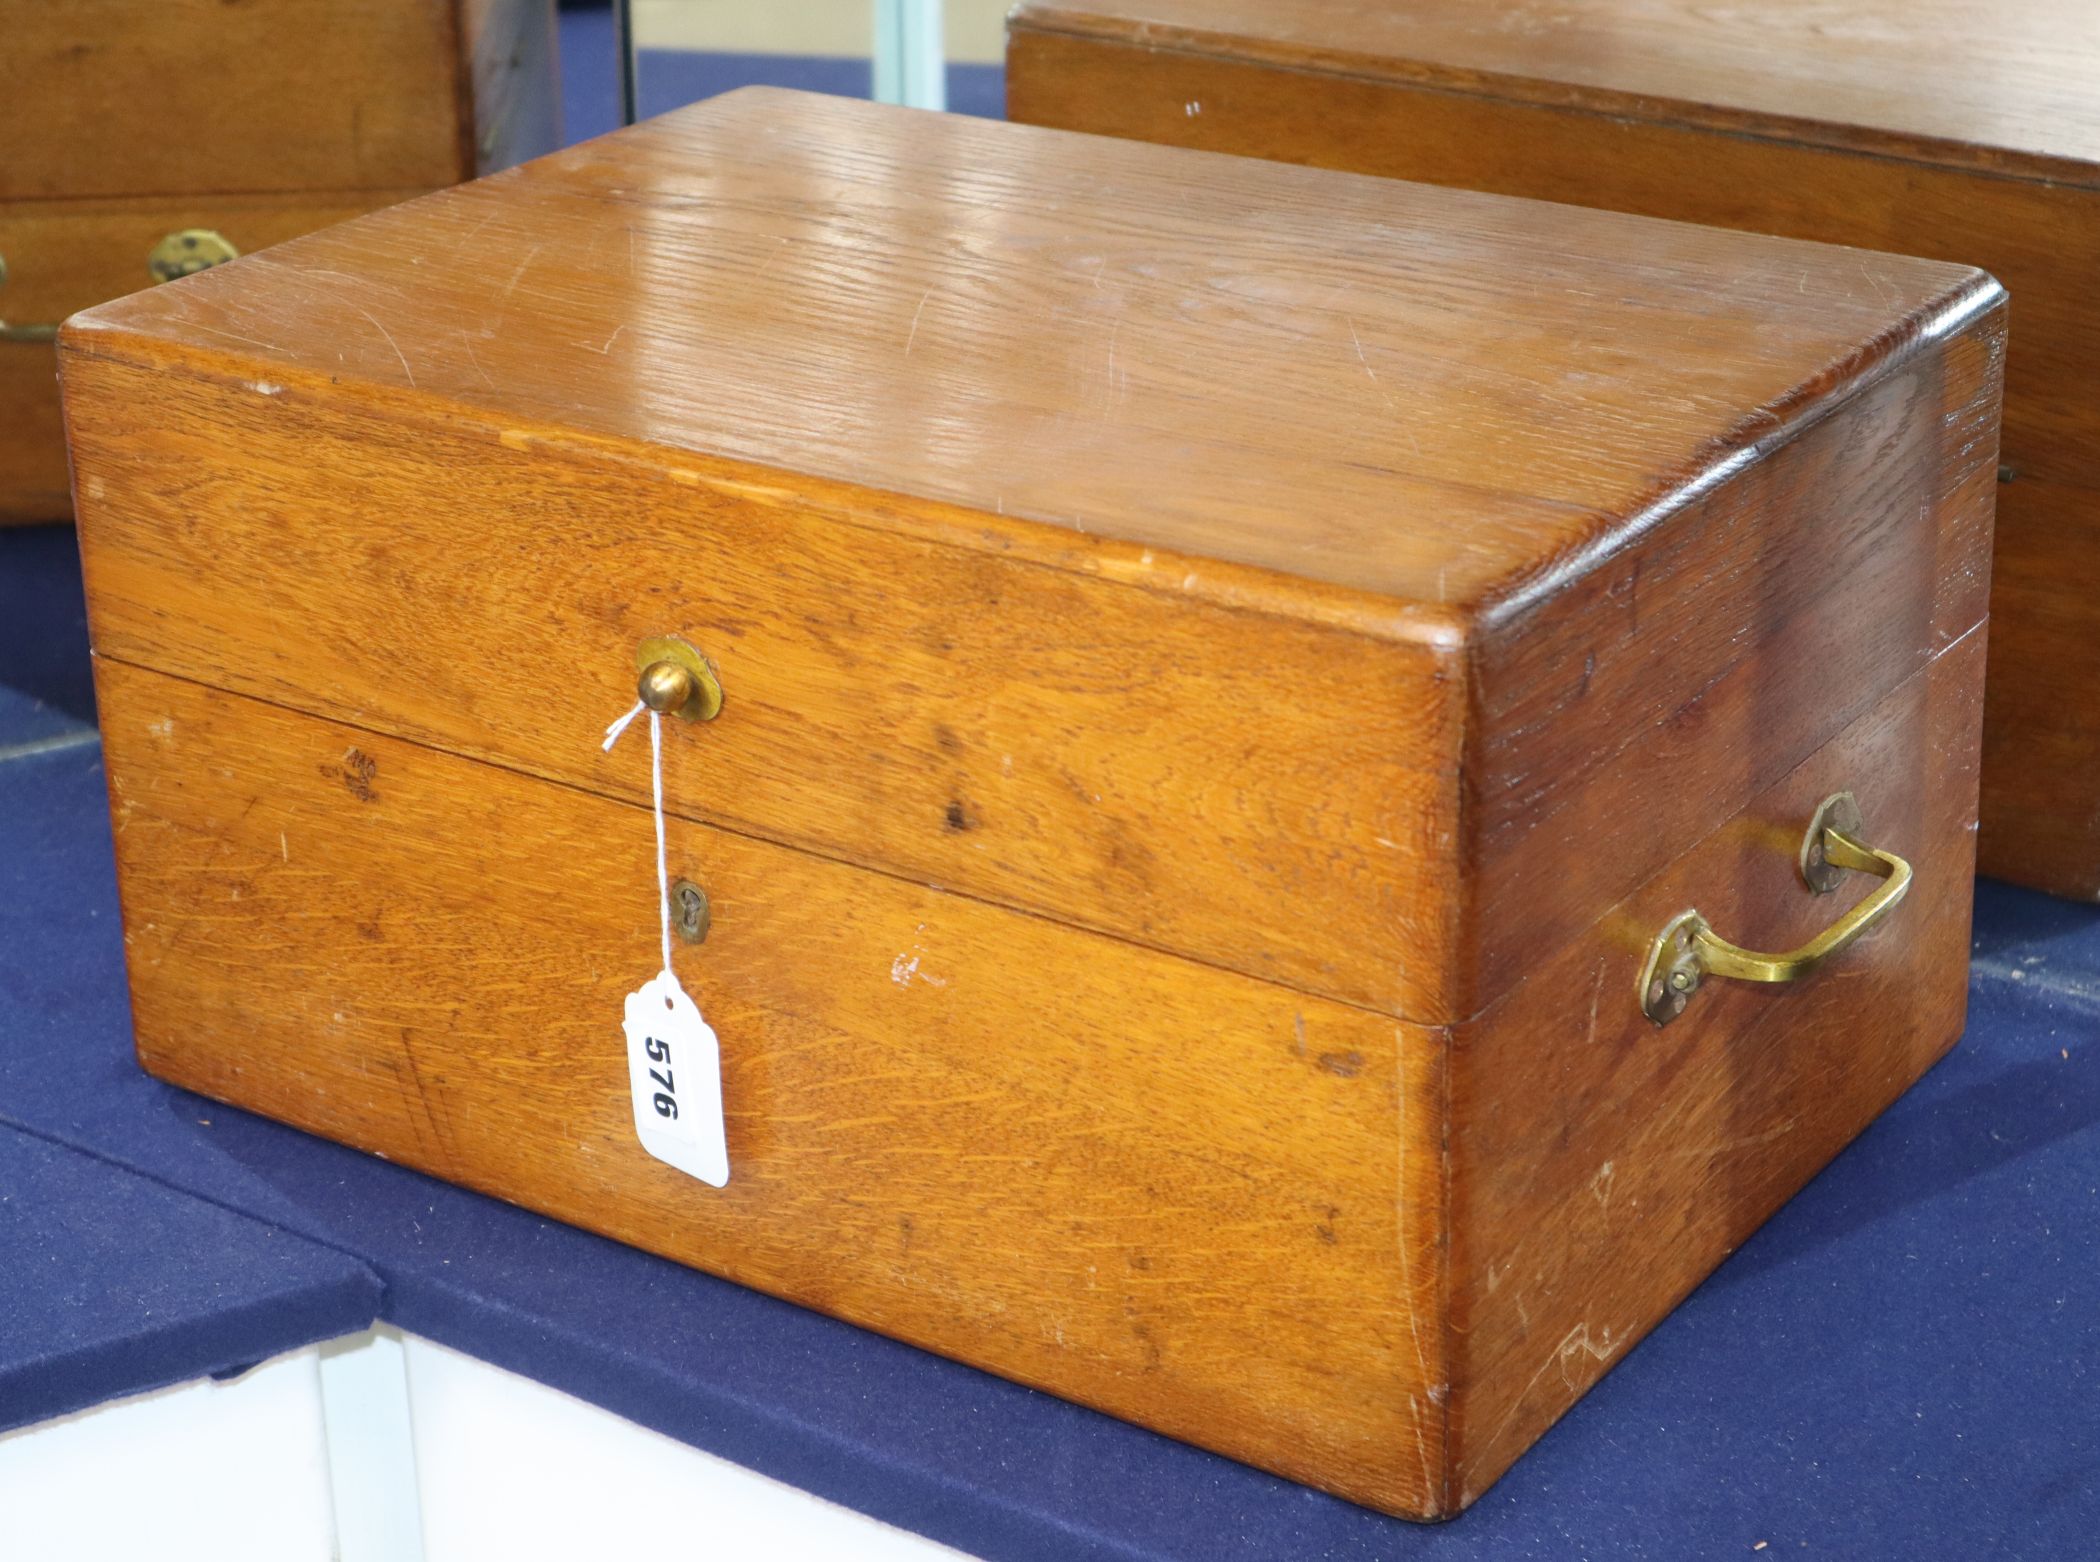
[69,293,2001,1022]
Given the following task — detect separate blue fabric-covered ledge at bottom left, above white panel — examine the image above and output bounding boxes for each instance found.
[0,1127,380,1432]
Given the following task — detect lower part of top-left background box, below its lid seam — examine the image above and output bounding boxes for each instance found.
[0,189,422,525]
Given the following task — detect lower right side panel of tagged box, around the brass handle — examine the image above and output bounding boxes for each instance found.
[1451,626,1985,1505]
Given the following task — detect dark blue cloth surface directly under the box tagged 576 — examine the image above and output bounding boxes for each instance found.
[0,520,2100,1562]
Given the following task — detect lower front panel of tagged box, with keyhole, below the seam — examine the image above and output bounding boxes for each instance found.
[99,661,1443,1514]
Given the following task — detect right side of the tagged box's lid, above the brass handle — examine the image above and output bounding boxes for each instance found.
[1466,309,2006,1004]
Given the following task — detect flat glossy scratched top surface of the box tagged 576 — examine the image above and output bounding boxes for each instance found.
[76,88,1995,634]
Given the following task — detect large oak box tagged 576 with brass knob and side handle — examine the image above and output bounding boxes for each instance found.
[61,90,2003,1516]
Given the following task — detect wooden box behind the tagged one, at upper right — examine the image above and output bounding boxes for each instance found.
[1006,0,2100,899]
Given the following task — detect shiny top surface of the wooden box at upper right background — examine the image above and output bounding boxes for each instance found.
[1010,0,2100,187]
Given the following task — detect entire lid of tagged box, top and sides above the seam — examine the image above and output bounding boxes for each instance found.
[63,90,2003,1020]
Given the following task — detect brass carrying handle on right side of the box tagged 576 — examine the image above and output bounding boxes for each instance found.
[1640,791,1911,1025]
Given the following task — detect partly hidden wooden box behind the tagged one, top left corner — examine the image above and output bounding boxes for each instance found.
[0,0,559,525]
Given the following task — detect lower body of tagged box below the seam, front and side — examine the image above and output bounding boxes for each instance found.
[86,617,1982,1516]
